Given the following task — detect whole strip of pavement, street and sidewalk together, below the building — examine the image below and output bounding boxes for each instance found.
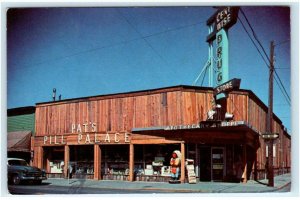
[8,174,291,194]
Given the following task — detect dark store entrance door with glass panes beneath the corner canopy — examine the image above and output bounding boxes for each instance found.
[211,147,225,181]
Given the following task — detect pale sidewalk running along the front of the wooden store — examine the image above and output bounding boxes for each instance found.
[43,174,291,193]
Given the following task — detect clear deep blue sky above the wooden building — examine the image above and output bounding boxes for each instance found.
[7,7,291,132]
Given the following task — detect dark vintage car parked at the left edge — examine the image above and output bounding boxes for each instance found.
[7,158,47,185]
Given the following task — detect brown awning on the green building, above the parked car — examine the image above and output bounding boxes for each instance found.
[7,131,31,152]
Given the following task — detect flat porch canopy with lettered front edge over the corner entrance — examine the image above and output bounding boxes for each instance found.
[132,121,261,148]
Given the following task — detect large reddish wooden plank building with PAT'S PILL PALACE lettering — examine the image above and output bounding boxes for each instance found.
[32,86,291,182]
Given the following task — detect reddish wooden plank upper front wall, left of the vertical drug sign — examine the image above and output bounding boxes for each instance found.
[36,91,212,136]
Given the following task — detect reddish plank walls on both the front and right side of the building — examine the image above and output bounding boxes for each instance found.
[35,89,290,169]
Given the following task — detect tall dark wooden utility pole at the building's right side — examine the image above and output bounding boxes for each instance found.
[267,41,274,187]
